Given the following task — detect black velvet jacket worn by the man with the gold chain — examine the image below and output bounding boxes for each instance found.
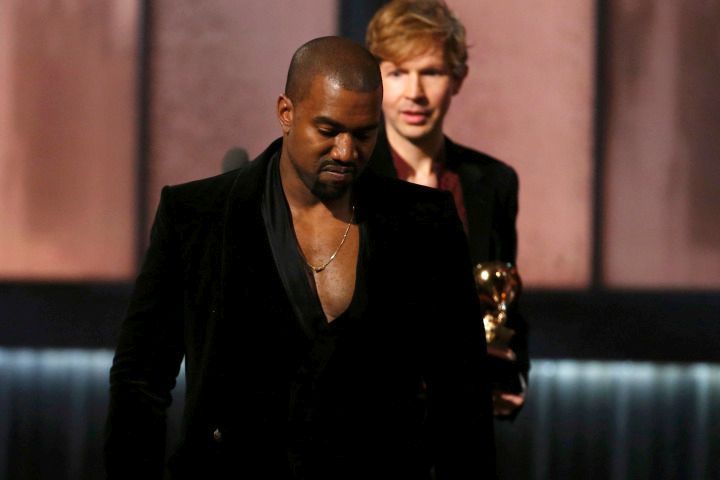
[105,140,494,479]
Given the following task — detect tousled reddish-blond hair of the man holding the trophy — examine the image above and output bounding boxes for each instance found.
[365,0,468,78]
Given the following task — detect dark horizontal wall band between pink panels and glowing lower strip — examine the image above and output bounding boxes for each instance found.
[0,283,720,362]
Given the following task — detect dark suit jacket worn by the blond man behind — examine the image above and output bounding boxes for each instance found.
[369,129,530,380]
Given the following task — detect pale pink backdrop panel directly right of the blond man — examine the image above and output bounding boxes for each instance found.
[447,0,596,288]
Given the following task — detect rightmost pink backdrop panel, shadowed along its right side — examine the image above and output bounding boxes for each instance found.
[603,0,720,290]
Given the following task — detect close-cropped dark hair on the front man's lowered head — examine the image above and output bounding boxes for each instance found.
[285,37,382,103]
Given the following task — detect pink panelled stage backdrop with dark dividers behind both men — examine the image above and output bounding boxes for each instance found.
[0,0,720,290]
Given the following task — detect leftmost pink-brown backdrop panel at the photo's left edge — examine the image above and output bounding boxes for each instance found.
[0,0,139,280]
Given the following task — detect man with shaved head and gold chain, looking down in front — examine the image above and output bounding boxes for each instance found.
[106,37,495,480]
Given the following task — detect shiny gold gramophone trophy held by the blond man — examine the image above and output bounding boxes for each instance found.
[474,261,522,392]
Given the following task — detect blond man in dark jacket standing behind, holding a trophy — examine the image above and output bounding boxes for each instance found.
[366,0,529,418]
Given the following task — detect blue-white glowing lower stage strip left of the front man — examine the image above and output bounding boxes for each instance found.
[0,348,184,480]
